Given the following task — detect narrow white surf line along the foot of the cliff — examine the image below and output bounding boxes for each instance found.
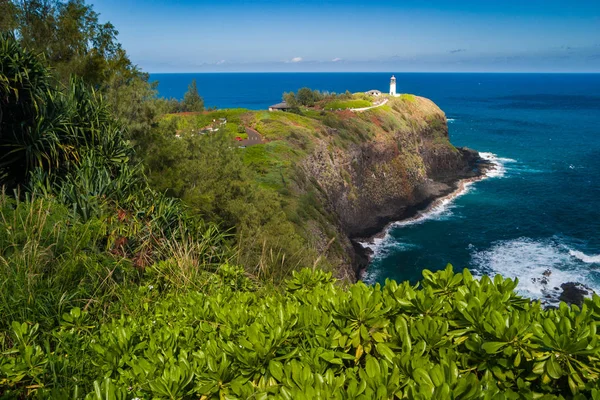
[350,152,492,281]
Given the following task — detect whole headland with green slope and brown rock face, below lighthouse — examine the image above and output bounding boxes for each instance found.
[166,95,486,281]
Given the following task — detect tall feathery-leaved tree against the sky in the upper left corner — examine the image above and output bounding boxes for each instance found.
[0,0,169,144]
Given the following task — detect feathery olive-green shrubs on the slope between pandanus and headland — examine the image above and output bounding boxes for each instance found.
[145,122,317,279]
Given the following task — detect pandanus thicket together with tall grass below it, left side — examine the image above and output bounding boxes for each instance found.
[0,27,227,344]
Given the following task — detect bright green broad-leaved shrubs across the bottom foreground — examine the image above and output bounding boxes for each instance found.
[0,266,600,399]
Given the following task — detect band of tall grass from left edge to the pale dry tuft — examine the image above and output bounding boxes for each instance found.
[0,193,229,331]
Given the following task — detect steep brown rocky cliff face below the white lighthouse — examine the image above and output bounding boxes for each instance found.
[302,96,479,278]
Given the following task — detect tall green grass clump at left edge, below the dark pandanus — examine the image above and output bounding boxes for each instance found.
[0,193,127,330]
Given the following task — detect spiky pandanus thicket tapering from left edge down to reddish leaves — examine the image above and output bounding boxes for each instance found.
[0,34,230,267]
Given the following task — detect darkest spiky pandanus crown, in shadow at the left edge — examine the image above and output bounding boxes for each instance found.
[0,33,68,187]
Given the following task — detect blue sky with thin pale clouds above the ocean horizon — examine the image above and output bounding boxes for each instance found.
[92,0,600,73]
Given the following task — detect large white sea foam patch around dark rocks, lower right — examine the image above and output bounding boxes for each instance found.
[471,238,600,302]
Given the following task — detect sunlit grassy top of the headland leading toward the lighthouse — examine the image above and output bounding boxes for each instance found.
[166,95,452,190]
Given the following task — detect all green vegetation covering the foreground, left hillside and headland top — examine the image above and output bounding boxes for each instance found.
[0,1,600,400]
